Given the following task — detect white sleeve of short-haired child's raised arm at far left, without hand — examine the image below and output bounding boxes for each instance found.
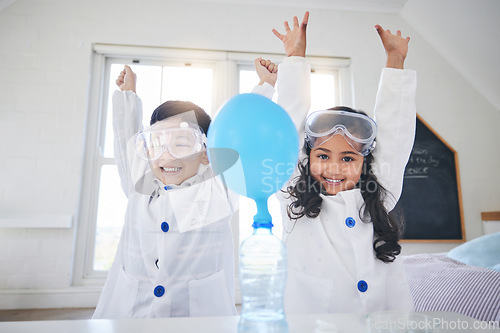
[112,91,146,197]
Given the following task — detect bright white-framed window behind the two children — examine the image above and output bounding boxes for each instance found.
[74,44,350,285]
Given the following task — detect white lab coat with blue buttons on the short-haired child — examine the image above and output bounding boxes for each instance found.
[93,91,237,318]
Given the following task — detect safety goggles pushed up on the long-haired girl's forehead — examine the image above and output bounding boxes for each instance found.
[305,110,377,156]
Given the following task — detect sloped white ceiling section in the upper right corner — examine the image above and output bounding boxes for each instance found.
[398,0,500,112]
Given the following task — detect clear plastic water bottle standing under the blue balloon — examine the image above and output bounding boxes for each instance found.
[238,222,288,333]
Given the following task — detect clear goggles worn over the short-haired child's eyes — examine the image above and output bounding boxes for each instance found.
[135,122,206,161]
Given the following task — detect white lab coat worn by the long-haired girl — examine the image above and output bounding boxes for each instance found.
[260,59,416,314]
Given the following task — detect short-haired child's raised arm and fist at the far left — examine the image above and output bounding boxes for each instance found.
[112,65,147,197]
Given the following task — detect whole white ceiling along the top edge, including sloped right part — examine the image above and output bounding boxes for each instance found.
[0,0,500,111]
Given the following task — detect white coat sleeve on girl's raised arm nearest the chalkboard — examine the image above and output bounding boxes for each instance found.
[373,68,417,211]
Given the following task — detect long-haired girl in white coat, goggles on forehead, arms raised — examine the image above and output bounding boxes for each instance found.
[256,13,416,313]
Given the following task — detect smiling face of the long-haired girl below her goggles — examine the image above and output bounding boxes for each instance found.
[309,135,364,195]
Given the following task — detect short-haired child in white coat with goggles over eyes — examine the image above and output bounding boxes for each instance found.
[93,66,236,318]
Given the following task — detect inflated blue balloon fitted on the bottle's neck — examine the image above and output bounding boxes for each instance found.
[207,94,299,226]
